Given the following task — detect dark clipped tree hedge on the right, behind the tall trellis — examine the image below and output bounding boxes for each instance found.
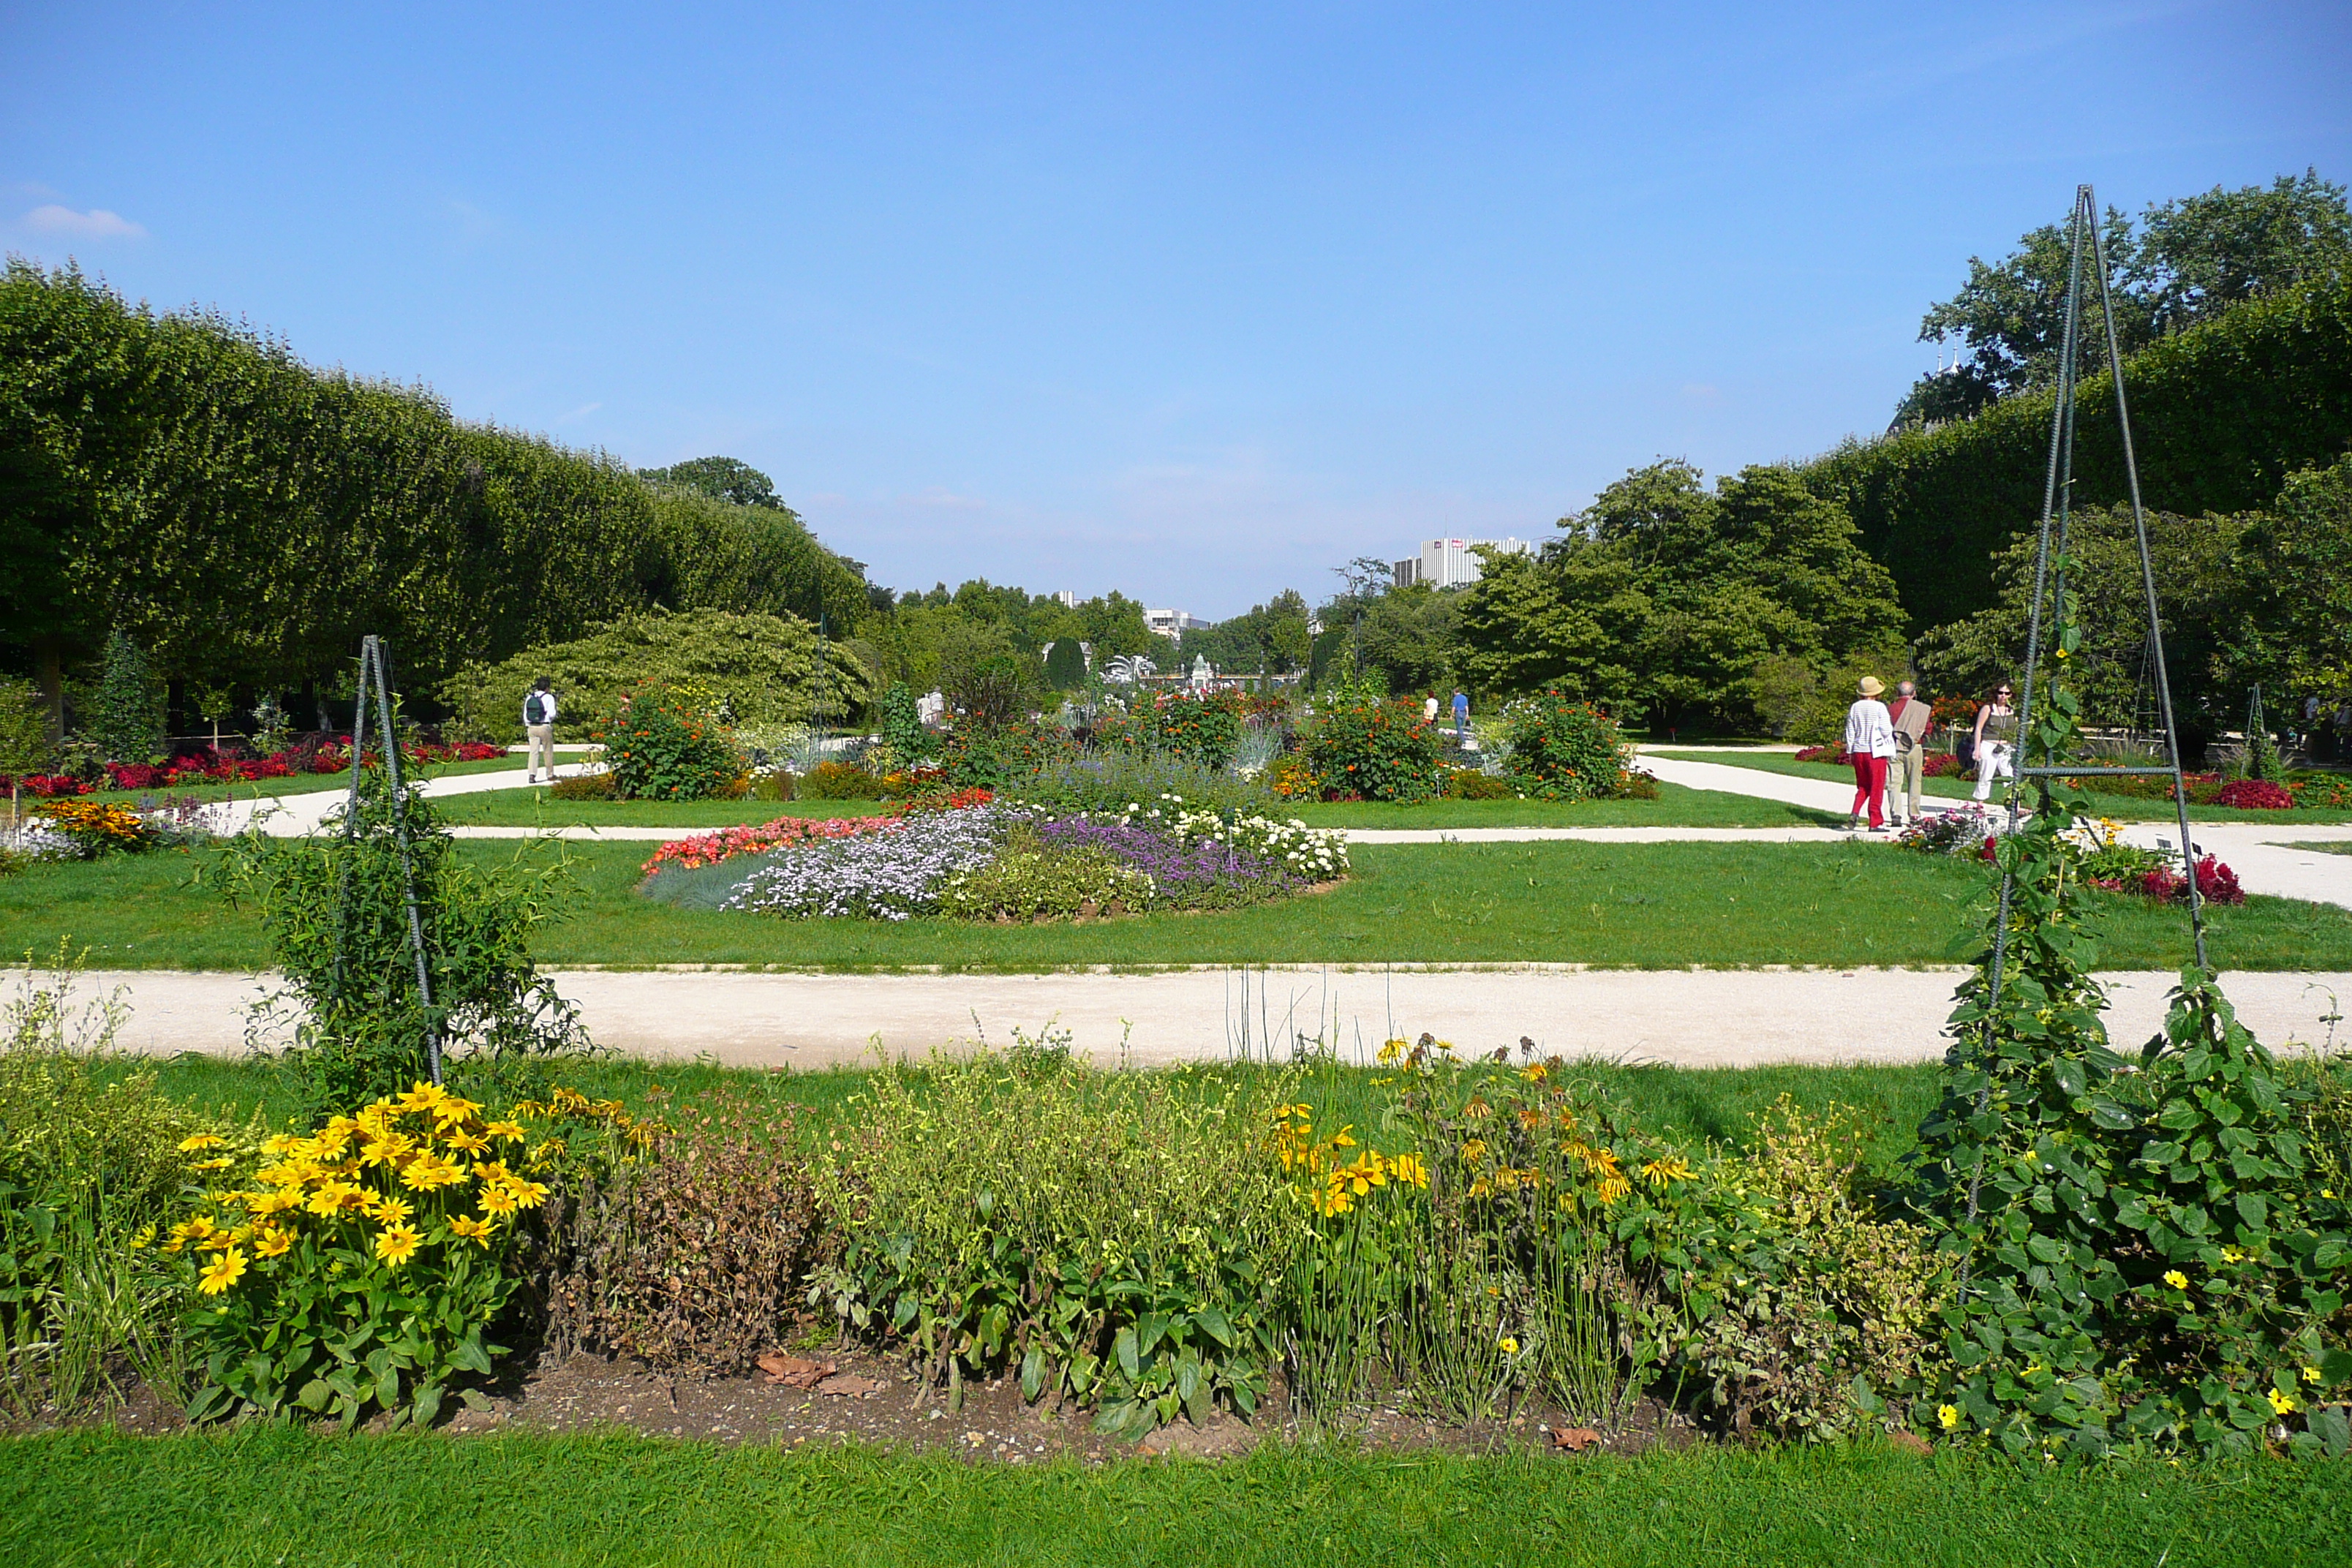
[1799,280,2352,630]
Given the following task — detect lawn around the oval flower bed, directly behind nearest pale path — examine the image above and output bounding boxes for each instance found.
[18,842,2352,971]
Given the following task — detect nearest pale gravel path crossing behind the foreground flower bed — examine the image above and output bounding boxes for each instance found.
[73,966,2352,1067]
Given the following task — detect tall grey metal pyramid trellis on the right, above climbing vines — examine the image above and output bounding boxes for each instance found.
[1971,186,2213,1020]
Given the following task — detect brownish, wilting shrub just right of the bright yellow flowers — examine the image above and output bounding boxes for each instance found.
[538,1098,835,1373]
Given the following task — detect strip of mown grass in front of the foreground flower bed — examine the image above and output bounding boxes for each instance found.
[0,1427,2352,1568]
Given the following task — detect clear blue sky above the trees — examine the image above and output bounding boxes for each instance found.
[0,0,2352,616]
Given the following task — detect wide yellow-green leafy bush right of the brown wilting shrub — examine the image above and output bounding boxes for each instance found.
[812,1037,1300,1436]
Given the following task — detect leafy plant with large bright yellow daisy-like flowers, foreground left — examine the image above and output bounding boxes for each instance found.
[180,1084,562,1429]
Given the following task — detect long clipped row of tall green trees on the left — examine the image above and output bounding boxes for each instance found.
[0,261,865,705]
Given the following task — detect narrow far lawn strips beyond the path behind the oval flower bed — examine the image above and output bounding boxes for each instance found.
[435,785,1844,832]
